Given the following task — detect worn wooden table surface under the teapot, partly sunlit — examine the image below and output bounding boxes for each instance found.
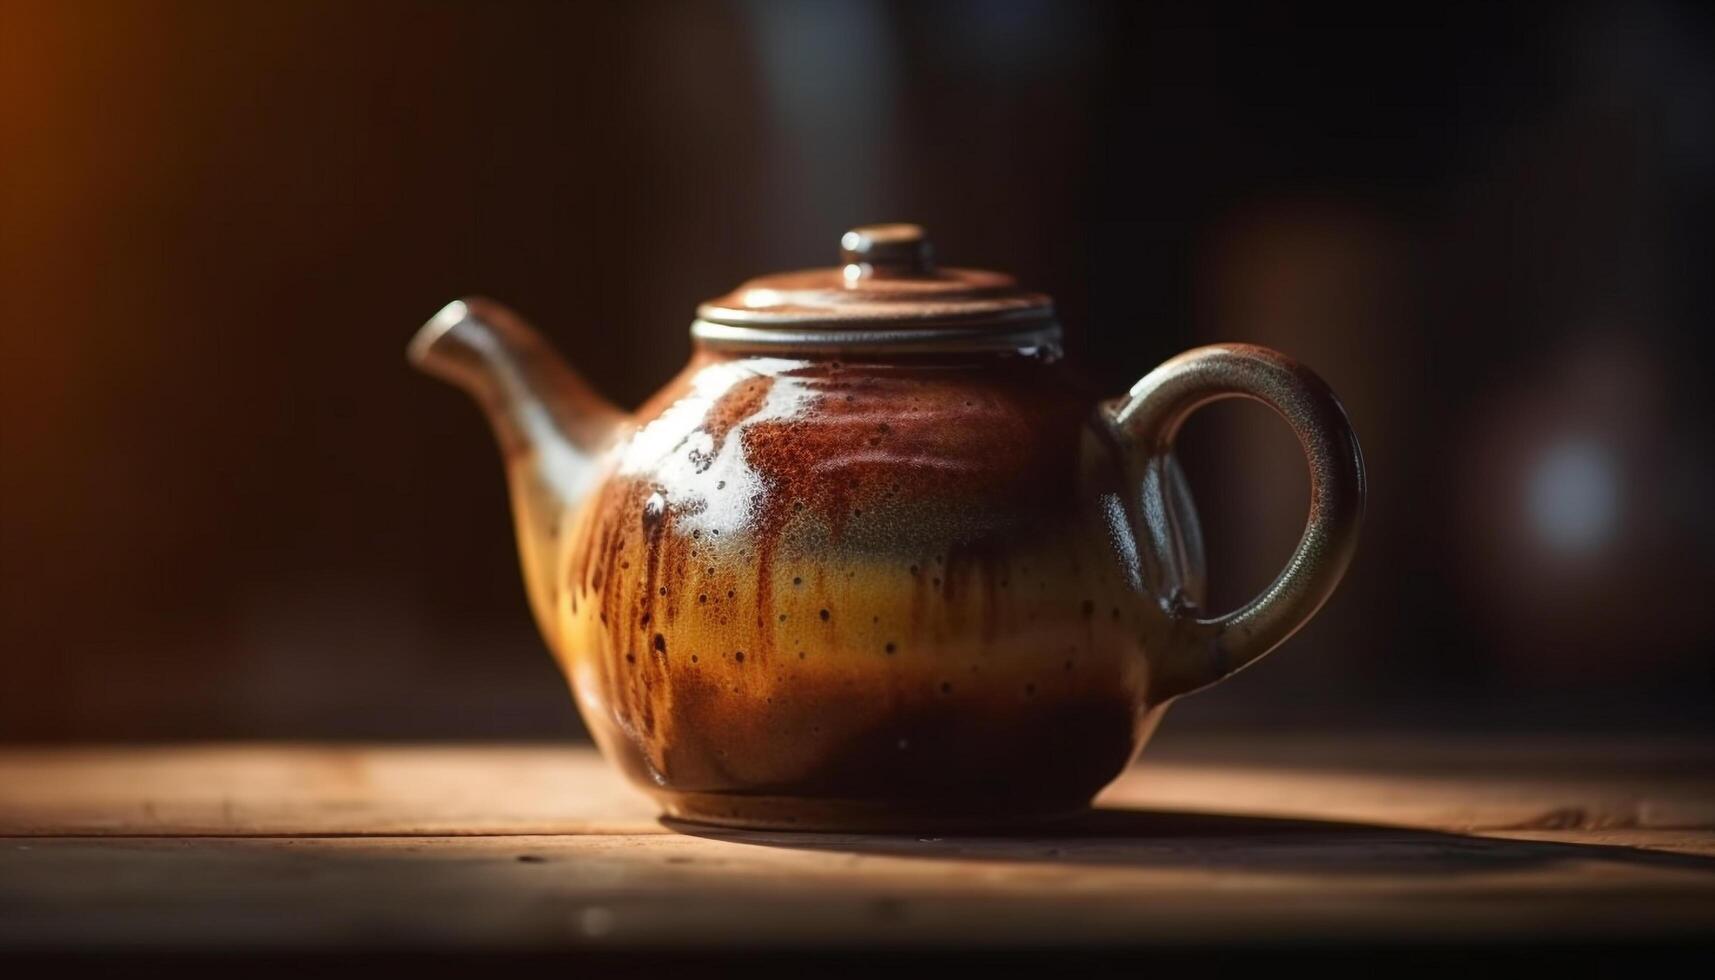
[0,735,1715,954]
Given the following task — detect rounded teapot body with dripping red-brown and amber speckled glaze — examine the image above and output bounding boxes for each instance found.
[544,350,1202,829]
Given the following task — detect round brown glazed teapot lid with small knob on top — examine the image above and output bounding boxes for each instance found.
[691,225,1060,350]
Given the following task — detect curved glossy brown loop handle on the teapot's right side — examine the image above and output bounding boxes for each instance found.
[1108,343,1365,700]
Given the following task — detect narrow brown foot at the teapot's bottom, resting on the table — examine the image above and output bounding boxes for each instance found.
[657,793,1091,834]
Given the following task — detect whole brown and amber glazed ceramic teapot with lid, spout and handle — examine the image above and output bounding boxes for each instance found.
[410,225,1363,831]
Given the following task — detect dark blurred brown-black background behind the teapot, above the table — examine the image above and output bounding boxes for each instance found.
[0,0,1715,740]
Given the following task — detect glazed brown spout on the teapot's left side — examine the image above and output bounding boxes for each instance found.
[406,297,626,642]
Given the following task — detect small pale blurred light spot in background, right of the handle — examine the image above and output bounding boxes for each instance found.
[1526,439,1619,551]
